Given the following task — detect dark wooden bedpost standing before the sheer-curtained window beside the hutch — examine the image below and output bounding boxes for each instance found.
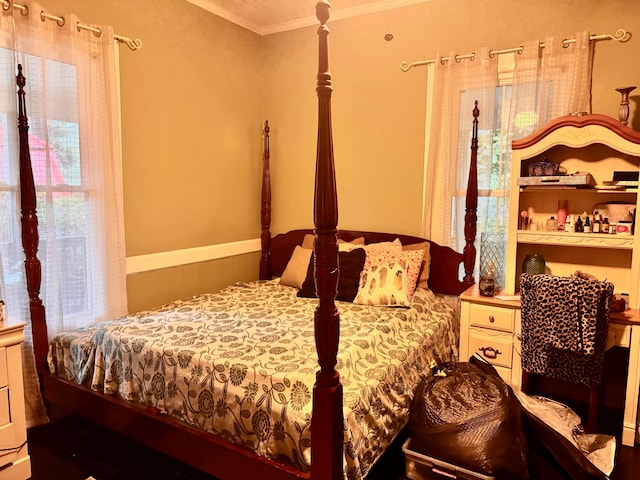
[462,100,480,286]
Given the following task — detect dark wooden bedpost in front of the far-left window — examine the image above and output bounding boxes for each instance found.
[16,65,49,369]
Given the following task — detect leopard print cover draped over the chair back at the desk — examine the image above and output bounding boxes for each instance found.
[520,273,613,387]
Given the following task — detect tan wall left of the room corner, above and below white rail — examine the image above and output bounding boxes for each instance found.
[41,0,264,311]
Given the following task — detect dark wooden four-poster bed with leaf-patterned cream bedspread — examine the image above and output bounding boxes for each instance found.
[18,1,478,480]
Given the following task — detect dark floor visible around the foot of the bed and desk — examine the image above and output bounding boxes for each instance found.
[28,408,640,480]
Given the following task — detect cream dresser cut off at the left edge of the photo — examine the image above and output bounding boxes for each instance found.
[0,322,31,480]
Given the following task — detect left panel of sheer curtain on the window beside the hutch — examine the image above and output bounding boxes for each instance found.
[422,48,498,251]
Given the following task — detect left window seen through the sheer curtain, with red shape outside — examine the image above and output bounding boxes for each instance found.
[0,50,93,317]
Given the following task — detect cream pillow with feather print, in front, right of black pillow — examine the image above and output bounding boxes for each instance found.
[353,260,411,307]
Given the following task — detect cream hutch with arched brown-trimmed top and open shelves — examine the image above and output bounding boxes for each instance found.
[505,114,640,308]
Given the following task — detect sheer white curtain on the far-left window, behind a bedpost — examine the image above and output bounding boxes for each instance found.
[0,2,127,425]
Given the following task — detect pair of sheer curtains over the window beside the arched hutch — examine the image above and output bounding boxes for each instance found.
[422,32,593,263]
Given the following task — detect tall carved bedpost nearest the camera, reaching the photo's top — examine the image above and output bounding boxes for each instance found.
[311,1,344,480]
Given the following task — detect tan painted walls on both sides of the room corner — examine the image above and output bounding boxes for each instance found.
[41,0,640,311]
